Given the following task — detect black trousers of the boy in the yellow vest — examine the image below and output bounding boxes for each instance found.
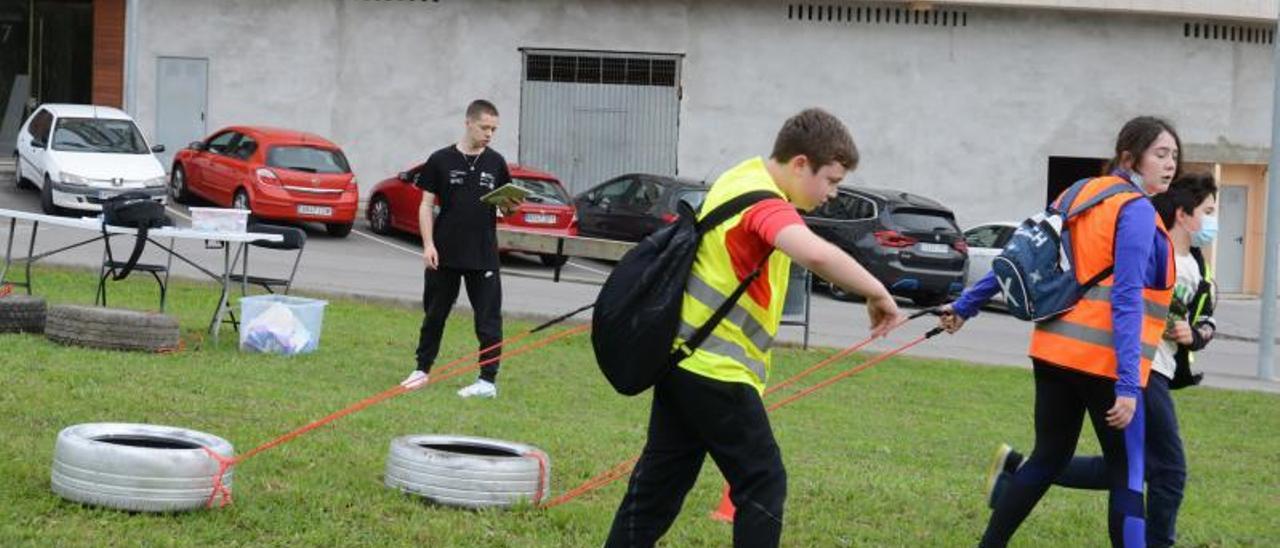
[605,367,787,547]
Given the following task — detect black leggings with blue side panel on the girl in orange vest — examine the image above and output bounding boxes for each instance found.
[982,360,1146,547]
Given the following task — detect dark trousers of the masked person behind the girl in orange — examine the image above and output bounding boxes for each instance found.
[1053,373,1187,547]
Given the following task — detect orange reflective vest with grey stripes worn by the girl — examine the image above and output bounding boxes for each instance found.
[1029,177,1176,387]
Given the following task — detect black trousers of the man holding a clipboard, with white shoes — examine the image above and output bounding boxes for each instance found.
[417,266,502,383]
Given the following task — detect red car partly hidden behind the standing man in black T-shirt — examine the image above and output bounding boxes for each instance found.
[366,164,577,266]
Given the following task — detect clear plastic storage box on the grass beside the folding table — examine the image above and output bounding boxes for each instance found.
[239,294,329,355]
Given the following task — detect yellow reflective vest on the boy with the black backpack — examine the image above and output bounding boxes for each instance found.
[675,157,791,394]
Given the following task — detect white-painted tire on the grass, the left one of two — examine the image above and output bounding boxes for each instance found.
[50,423,236,512]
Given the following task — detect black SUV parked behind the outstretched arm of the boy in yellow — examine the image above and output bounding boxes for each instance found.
[804,187,969,306]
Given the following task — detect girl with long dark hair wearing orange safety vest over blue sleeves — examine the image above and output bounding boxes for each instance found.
[941,117,1181,547]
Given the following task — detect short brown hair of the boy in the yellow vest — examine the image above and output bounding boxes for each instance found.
[769,109,858,172]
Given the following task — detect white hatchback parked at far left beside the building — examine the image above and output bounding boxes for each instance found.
[14,104,165,214]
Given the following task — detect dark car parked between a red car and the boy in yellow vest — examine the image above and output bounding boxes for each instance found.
[575,173,707,242]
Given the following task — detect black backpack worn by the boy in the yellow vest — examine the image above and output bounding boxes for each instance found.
[591,191,778,396]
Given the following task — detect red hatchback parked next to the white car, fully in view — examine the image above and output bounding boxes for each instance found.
[169,125,360,238]
